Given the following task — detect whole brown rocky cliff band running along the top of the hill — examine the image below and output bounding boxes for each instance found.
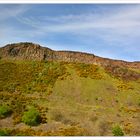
[0,42,140,69]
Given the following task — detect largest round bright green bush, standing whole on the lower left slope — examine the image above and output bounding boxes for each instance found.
[22,107,40,126]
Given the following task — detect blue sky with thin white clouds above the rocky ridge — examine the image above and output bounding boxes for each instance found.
[0,4,140,61]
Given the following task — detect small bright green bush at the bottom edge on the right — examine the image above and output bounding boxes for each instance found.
[112,125,124,136]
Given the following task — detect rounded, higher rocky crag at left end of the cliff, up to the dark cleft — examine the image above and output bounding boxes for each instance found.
[0,43,50,60]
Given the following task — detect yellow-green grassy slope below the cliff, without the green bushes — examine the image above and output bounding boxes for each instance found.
[0,60,140,135]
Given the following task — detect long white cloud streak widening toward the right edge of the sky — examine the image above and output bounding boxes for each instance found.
[17,5,140,32]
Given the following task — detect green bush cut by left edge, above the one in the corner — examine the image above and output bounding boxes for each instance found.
[0,105,12,118]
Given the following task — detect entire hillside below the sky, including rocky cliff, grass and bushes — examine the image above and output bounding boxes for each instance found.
[0,43,140,136]
